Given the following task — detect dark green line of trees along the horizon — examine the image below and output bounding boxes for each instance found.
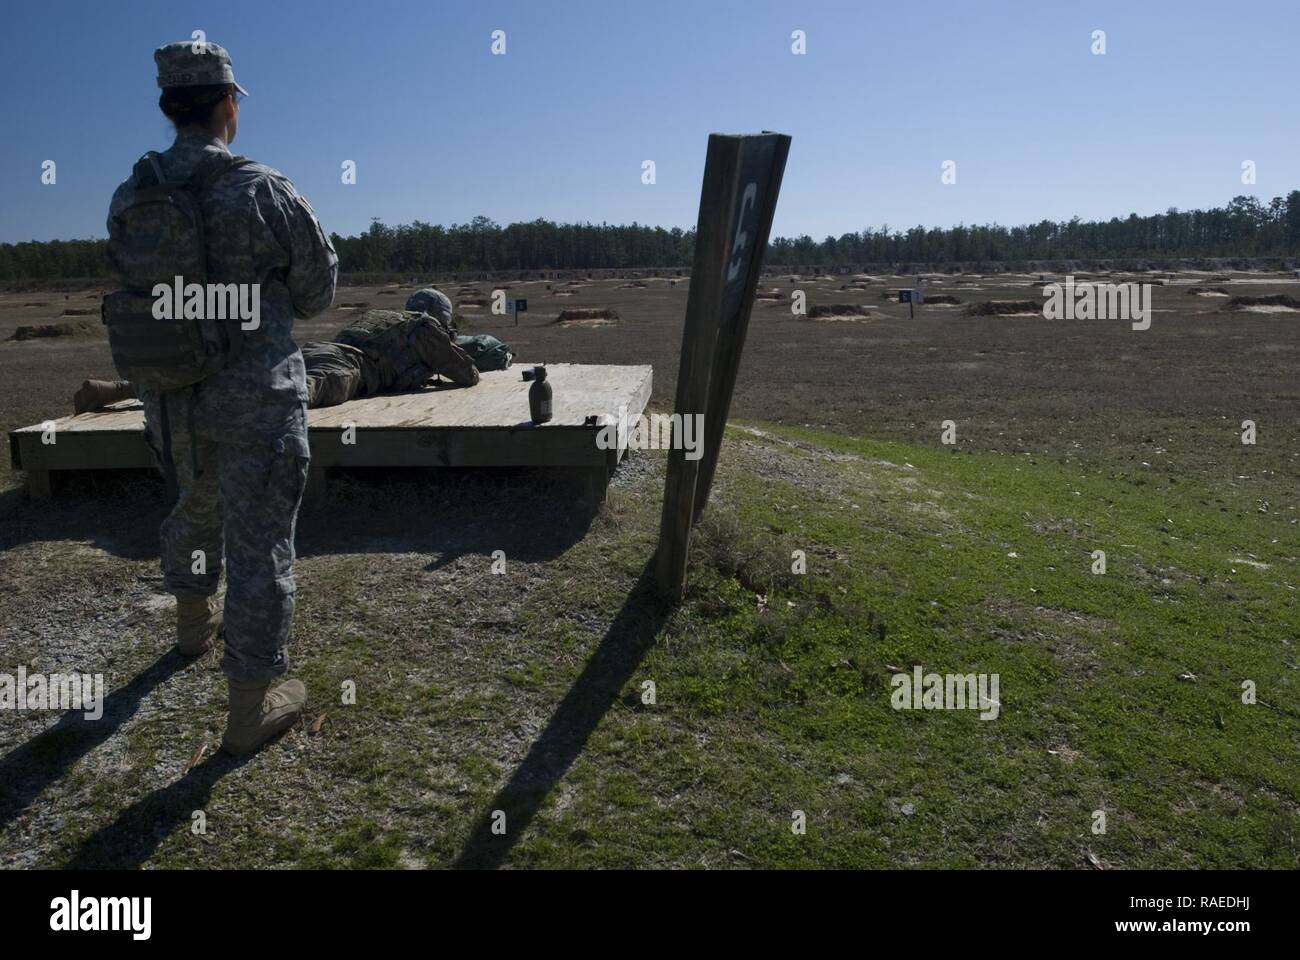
[0,190,1300,281]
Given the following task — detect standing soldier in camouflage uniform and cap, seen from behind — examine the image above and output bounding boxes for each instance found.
[104,40,338,753]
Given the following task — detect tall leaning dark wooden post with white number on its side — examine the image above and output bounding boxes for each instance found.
[654,133,790,598]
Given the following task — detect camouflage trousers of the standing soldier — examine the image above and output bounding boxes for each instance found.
[142,390,308,682]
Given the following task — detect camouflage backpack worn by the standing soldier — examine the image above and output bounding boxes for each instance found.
[100,151,252,392]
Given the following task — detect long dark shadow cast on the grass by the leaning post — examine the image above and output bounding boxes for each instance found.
[452,565,673,869]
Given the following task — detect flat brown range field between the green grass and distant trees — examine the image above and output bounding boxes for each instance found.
[0,267,1300,487]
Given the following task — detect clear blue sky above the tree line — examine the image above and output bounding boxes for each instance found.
[0,0,1300,242]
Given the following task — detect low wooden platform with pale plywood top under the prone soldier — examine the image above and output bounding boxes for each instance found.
[9,363,651,503]
